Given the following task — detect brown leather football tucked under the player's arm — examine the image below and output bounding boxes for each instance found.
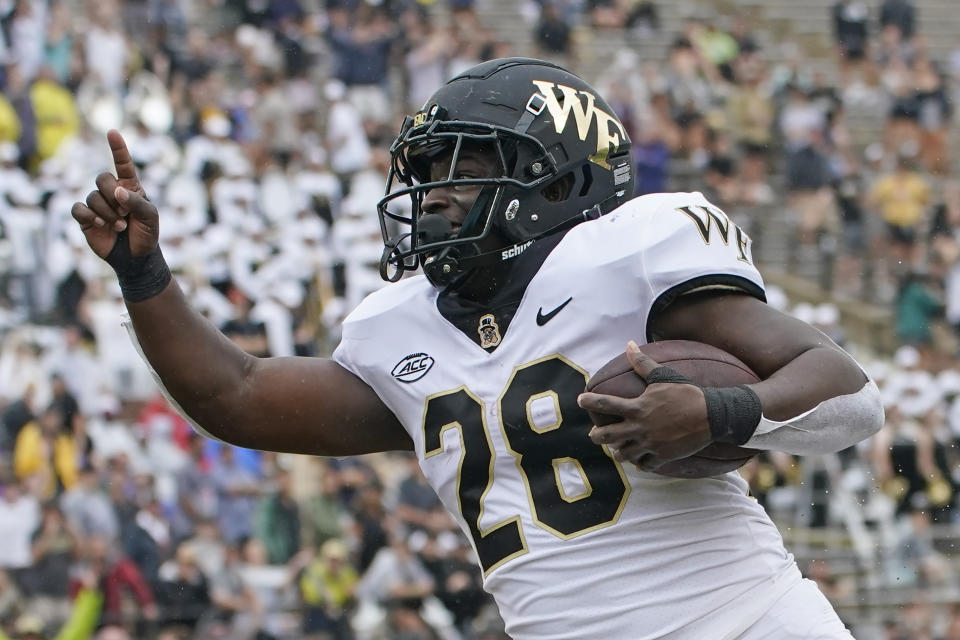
[586,340,760,478]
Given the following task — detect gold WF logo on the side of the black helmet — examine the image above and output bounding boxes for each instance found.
[533,80,627,169]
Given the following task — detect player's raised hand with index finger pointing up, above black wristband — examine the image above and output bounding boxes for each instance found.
[71,130,160,259]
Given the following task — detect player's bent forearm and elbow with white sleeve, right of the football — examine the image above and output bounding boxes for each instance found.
[744,347,883,455]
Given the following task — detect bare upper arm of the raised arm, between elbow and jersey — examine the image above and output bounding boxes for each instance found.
[235,358,413,456]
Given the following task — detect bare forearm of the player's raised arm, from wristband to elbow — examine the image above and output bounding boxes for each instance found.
[127,280,256,439]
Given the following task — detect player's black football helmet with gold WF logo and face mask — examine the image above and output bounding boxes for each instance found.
[377,58,633,286]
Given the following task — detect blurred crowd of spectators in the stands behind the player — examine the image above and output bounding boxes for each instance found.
[0,0,960,640]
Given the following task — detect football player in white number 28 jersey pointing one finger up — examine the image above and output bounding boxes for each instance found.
[73,58,883,640]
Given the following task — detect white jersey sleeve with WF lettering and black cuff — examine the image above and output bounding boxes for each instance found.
[640,193,766,339]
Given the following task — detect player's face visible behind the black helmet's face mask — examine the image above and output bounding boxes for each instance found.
[421,148,498,233]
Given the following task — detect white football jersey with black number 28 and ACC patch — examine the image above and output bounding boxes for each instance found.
[334,193,800,640]
